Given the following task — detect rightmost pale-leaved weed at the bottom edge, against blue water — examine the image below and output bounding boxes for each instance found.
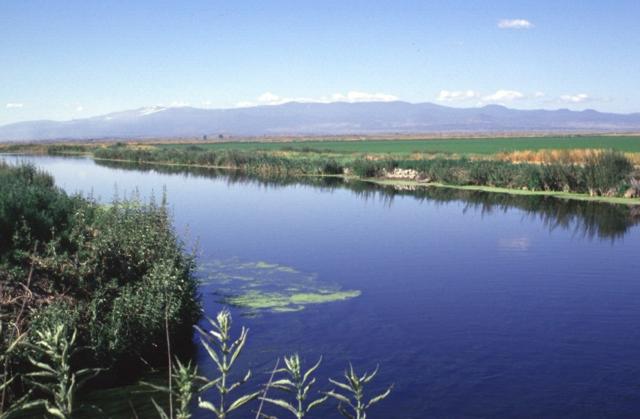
[327,364,393,419]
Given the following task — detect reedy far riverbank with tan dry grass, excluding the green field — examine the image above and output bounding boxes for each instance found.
[5,139,640,205]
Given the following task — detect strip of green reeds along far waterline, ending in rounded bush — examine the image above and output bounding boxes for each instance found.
[94,145,640,196]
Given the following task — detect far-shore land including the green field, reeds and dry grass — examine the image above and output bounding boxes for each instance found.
[5,135,640,205]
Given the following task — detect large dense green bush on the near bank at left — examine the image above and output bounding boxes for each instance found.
[0,163,200,417]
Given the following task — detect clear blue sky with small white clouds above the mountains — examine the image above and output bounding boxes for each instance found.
[0,0,640,124]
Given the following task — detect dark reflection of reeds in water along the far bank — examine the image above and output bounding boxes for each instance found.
[96,161,640,240]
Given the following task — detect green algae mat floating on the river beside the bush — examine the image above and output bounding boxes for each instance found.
[200,259,360,315]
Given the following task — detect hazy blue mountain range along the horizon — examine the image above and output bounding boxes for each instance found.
[0,101,640,141]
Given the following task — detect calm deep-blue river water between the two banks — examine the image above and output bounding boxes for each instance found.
[3,157,640,418]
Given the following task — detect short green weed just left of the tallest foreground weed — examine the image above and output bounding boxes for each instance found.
[143,359,202,419]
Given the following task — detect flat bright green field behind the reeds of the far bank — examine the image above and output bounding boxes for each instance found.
[159,136,640,154]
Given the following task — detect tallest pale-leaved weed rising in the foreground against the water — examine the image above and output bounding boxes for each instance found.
[196,309,260,419]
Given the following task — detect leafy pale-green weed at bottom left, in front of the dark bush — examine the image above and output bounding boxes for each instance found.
[26,325,101,419]
